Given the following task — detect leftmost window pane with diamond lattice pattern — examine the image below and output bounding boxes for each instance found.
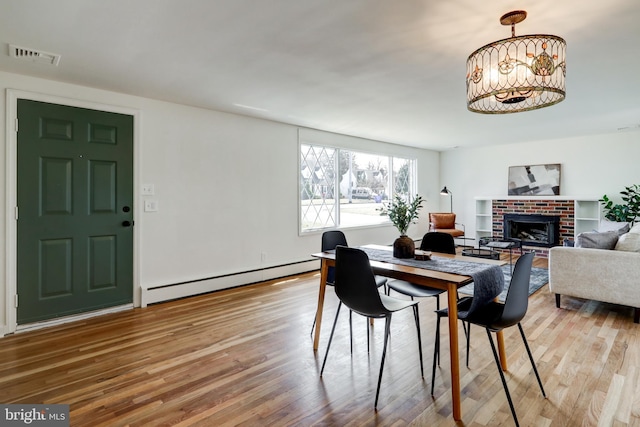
[300,144,338,230]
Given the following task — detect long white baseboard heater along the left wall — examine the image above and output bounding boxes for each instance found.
[141,259,320,307]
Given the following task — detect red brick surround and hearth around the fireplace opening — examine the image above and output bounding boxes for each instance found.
[491,199,575,257]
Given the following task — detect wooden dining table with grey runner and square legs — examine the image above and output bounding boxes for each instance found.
[312,245,507,421]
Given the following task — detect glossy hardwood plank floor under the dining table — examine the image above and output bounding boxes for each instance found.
[0,259,640,427]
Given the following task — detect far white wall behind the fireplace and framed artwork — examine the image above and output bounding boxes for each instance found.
[440,135,640,236]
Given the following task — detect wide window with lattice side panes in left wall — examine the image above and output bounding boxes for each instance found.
[300,144,416,232]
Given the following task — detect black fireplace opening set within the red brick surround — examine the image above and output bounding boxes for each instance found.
[503,214,560,248]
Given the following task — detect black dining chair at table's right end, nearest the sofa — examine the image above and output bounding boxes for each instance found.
[431,252,547,426]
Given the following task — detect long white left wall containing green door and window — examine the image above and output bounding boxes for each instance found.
[0,72,440,333]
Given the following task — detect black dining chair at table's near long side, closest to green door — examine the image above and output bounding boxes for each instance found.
[320,246,424,407]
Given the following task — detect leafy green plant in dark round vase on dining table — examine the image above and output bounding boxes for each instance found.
[380,194,424,258]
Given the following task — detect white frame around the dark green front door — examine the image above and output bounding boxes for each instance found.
[5,89,142,336]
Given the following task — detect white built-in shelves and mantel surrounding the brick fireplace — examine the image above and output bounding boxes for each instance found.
[475,196,602,241]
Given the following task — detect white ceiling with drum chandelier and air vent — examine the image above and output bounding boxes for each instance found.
[0,0,640,150]
